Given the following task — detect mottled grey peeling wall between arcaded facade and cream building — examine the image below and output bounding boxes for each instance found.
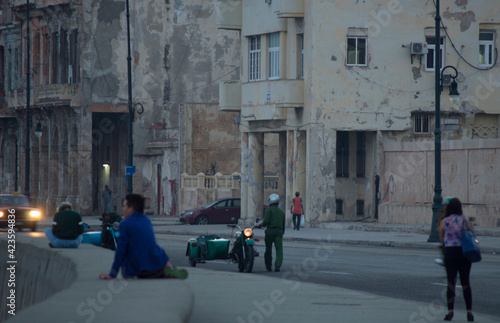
[84,0,240,214]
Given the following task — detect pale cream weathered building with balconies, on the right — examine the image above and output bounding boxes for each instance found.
[217,0,500,226]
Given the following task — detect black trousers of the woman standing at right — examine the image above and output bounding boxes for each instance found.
[444,247,472,311]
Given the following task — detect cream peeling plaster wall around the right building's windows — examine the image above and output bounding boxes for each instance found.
[242,0,500,222]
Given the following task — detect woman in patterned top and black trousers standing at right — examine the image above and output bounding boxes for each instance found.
[439,198,474,322]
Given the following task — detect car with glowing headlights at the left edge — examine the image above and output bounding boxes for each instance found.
[0,194,42,231]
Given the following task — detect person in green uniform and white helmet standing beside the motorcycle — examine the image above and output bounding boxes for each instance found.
[258,194,285,272]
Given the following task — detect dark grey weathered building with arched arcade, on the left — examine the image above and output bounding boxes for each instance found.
[0,0,240,215]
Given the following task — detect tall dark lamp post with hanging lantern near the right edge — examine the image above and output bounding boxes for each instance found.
[427,0,459,242]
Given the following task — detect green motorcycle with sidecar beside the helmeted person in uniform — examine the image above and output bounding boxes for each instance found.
[186,219,259,273]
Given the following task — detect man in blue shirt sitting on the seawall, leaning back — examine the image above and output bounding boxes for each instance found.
[99,194,188,279]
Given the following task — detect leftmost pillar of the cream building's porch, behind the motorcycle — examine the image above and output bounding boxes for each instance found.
[246,132,264,224]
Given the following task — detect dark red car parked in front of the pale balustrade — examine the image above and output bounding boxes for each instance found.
[180,198,241,224]
